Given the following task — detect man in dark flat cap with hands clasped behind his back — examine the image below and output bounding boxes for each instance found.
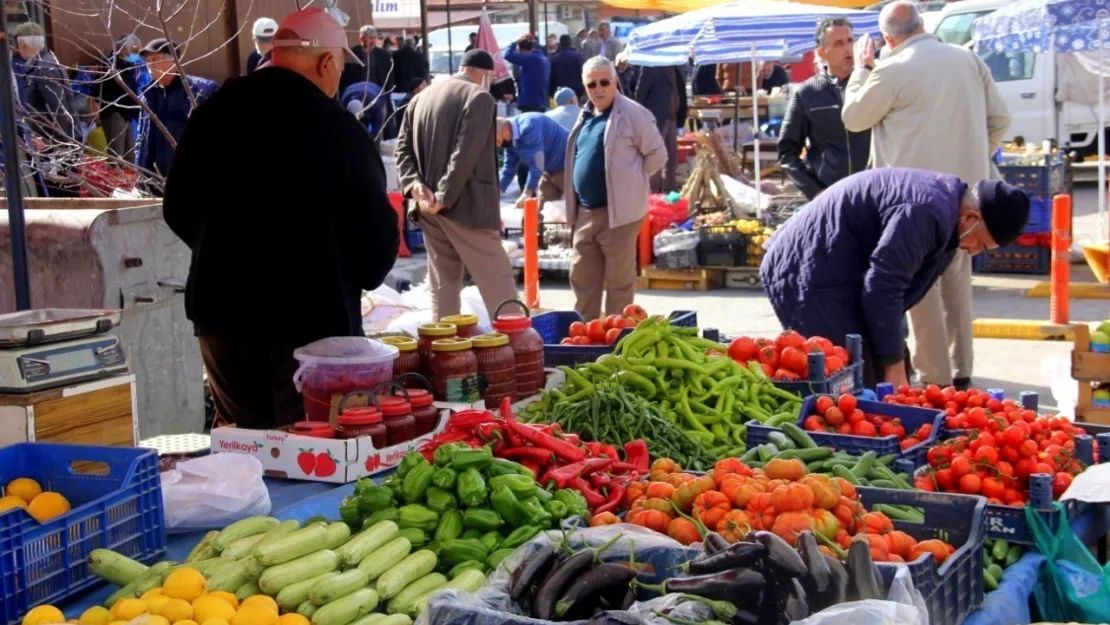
[394,50,516,319]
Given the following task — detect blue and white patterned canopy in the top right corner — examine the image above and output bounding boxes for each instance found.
[971,0,1110,52]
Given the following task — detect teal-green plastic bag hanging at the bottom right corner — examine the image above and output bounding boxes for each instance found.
[1026,503,1110,623]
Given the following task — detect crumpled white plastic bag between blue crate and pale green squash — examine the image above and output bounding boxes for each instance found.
[161,454,270,532]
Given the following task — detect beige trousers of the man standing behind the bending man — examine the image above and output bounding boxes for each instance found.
[909,250,973,385]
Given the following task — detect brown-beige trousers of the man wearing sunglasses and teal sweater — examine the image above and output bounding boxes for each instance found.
[571,206,643,320]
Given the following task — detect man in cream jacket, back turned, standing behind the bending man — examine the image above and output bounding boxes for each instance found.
[841,0,1010,386]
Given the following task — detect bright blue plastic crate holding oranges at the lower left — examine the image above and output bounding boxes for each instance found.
[0,443,165,624]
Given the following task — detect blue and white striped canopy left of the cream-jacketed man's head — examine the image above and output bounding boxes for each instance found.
[628,0,874,65]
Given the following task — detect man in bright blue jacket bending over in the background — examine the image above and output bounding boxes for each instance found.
[497,113,569,210]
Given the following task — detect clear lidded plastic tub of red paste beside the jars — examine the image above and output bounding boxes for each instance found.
[293,336,398,422]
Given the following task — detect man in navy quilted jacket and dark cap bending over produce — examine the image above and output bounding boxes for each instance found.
[759,168,1029,387]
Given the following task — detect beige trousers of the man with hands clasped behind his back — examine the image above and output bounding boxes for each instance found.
[420,213,517,319]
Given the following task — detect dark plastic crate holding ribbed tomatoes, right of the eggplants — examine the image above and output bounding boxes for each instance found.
[856,486,987,625]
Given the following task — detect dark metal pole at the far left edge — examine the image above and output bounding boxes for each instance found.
[0,1,31,311]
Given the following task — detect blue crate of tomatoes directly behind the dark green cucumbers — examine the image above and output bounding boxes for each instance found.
[748,396,945,468]
